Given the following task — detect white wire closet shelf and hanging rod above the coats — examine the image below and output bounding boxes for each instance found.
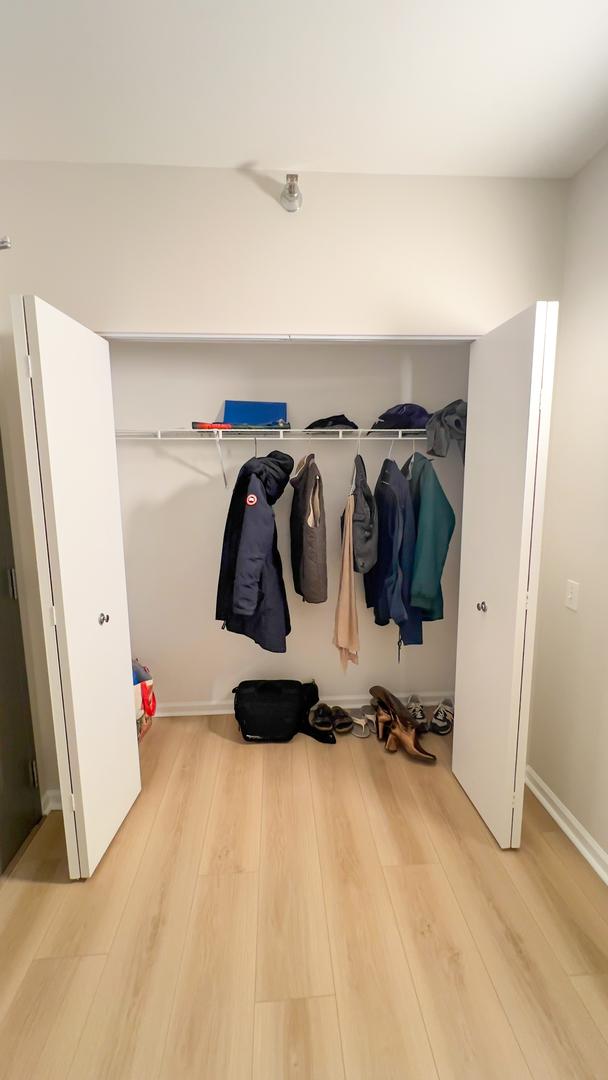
[116,428,427,443]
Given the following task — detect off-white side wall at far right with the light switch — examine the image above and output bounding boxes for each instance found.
[529,141,608,851]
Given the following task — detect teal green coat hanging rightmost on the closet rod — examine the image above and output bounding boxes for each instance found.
[403,454,456,622]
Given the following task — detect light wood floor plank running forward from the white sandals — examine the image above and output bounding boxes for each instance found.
[351,737,437,866]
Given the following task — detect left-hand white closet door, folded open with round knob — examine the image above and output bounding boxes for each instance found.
[17,297,140,877]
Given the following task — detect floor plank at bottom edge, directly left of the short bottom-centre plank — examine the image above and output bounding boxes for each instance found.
[160,874,258,1080]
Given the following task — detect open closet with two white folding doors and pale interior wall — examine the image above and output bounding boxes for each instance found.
[13,297,557,878]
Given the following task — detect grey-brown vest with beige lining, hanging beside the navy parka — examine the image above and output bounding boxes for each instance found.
[289,454,327,604]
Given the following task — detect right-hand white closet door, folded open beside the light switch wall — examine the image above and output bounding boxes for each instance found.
[452,302,557,848]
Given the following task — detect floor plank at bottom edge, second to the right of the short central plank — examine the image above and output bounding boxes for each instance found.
[384,866,530,1080]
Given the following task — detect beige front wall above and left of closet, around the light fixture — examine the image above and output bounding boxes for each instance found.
[0,162,568,803]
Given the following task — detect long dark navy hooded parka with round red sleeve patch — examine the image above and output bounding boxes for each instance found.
[216,450,294,652]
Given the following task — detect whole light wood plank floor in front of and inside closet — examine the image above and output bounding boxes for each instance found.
[0,717,608,1080]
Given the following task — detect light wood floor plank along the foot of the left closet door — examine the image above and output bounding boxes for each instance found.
[38,719,183,957]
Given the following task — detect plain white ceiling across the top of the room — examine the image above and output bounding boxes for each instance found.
[0,0,608,176]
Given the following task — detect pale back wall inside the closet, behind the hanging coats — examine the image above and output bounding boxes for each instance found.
[112,345,469,712]
